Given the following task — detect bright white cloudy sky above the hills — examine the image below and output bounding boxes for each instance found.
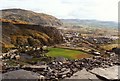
[0,0,120,21]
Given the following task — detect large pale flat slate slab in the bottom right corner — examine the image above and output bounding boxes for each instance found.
[90,66,120,80]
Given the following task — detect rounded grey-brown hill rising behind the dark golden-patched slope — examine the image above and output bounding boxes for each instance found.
[0,9,62,26]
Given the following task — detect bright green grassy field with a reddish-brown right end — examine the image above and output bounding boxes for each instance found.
[47,48,91,59]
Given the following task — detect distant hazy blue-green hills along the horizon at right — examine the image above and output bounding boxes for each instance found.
[61,19,118,28]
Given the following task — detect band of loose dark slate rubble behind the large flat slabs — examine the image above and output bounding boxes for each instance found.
[2,56,120,81]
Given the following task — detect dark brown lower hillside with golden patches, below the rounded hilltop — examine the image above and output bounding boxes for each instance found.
[2,22,62,47]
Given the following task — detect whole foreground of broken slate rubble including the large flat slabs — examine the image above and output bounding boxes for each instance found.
[4,54,118,81]
